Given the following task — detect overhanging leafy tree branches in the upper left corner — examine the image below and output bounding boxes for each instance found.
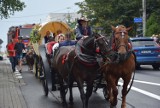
[0,0,26,19]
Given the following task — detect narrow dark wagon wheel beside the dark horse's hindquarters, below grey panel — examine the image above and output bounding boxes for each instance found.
[40,62,49,96]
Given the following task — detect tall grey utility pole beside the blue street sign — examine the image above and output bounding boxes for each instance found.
[142,0,146,36]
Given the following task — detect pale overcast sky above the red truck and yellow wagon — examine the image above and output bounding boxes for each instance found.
[0,0,84,51]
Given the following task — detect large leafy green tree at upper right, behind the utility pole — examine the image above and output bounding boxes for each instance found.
[76,0,160,36]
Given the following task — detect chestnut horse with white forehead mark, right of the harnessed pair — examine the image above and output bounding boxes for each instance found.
[101,25,135,108]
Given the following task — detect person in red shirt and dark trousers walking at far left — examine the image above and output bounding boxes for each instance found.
[7,39,17,72]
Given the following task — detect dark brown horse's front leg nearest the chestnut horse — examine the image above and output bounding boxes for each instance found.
[85,81,93,108]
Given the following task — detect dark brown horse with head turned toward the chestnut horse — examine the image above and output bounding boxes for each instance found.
[52,34,108,108]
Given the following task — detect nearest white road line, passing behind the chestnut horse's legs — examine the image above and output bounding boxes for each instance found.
[118,82,160,100]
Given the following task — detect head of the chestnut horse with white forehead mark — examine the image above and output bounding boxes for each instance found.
[111,25,131,60]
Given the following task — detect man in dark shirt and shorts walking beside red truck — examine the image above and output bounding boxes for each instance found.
[14,37,25,73]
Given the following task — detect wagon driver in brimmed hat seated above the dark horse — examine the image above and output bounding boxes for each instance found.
[75,16,92,40]
